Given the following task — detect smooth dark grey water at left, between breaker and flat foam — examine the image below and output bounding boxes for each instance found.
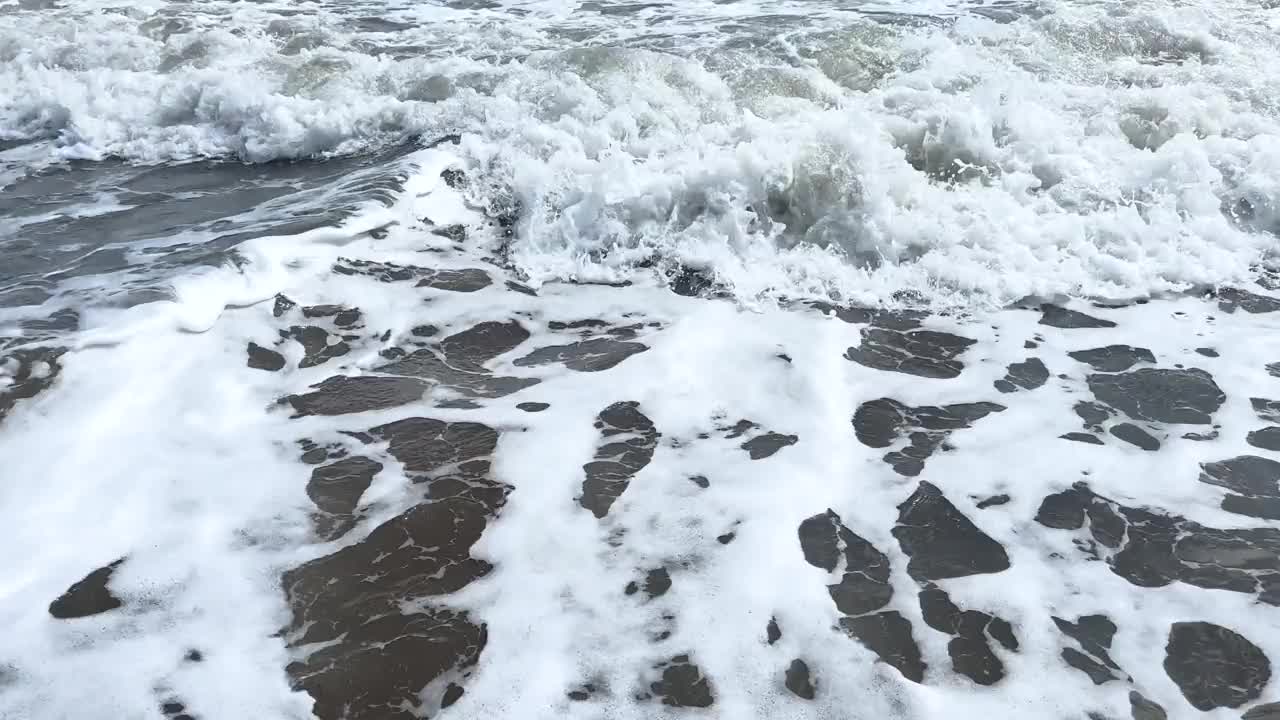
[0,145,415,340]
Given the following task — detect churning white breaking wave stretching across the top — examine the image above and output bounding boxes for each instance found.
[0,1,1280,305]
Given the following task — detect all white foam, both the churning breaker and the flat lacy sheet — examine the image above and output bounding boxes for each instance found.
[0,1,1280,720]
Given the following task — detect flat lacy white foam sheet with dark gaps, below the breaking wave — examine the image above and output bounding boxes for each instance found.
[0,142,1280,720]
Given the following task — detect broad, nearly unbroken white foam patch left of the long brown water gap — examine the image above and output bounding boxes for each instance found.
[0,147,451,720]
